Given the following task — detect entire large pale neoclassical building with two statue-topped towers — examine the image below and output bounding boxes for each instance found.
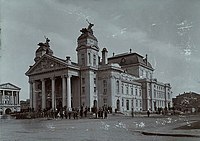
[26,23,172,112]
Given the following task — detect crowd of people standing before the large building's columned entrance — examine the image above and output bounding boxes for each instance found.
[17,106,112,119]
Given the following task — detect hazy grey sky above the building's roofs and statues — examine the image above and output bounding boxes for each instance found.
[0,0,200,100]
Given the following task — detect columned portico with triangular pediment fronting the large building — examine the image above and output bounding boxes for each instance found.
[26,54,80,111]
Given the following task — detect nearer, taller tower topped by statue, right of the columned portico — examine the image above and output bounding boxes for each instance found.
[76,22,99,108]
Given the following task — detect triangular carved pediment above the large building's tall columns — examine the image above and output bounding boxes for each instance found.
[26,54,67,76]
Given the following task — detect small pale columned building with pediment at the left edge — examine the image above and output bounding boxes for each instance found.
[0,83,21,115]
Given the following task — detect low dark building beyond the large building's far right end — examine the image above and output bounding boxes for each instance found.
[172,92,200,113]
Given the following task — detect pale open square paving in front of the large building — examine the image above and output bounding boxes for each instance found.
[0,115,200,141]
